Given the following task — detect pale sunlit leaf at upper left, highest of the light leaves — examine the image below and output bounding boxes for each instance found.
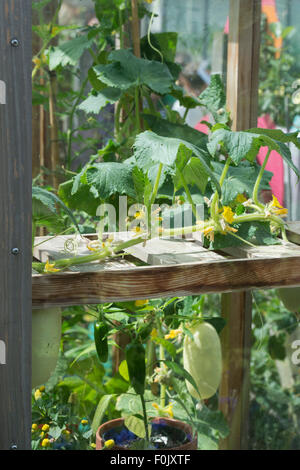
[49,34,93,70]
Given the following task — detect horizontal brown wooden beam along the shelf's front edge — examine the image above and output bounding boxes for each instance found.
[33,255,300,306]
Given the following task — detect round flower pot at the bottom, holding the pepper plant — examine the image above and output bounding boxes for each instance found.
[97,418,197,450]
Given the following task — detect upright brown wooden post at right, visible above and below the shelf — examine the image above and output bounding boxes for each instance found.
[220,0,261,450]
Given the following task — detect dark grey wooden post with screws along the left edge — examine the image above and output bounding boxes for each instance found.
[0,0,32,450]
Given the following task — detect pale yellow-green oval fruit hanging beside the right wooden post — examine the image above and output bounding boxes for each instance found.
[183,322,222,400]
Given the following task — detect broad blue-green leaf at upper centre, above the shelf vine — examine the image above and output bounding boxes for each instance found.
[94,49,174,95]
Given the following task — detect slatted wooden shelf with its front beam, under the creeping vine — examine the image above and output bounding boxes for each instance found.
[32,223,300,307]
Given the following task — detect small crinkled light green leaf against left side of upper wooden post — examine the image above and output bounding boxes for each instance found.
[199,74,229,124]
